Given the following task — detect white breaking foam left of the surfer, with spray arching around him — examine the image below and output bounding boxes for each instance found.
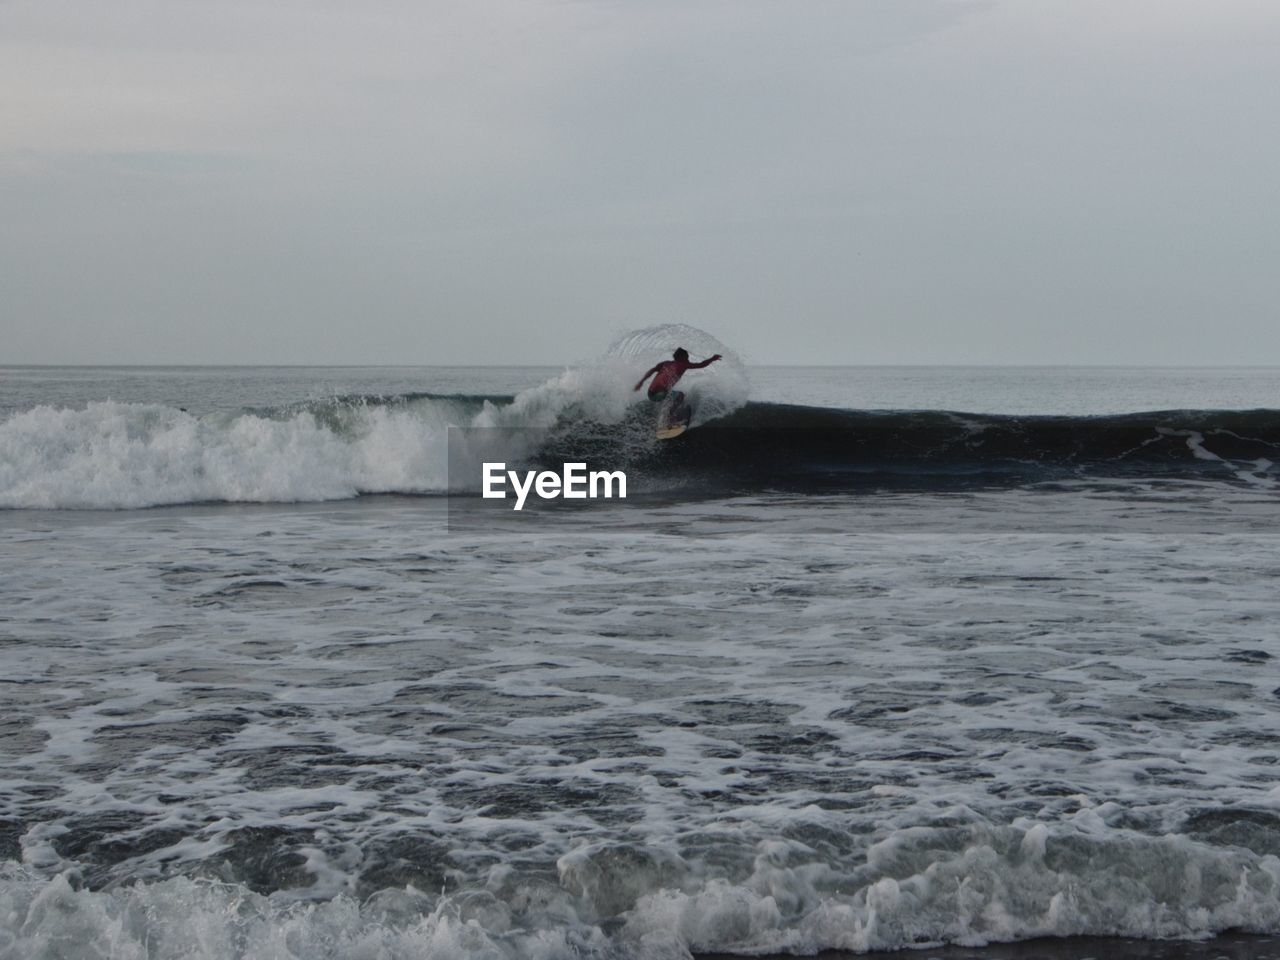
[0,325,746,509]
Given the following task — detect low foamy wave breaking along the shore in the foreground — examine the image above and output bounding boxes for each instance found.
[0,809,1280,960]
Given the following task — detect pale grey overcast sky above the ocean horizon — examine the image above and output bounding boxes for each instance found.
[0,0,1280,364]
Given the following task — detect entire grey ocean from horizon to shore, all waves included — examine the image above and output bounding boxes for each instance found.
[0,328,1280,960]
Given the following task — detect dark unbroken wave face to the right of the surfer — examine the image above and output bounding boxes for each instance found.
[637,403,1280,488]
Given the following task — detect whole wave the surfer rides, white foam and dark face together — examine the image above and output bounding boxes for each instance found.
[0,394,1280,508]
